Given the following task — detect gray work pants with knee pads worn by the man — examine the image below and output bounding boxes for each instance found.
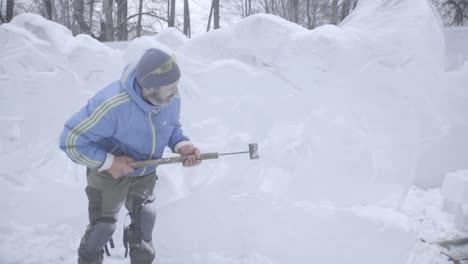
[78,168,157,264]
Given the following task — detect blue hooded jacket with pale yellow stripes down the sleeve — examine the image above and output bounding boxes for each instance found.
[60,65,189,176]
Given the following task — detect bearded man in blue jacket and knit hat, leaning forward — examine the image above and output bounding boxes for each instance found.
[60,49,200,264]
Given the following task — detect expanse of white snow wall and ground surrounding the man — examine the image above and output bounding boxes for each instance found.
[0,0,468,264]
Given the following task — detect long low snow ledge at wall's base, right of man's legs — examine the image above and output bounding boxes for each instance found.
[154,193,415,264]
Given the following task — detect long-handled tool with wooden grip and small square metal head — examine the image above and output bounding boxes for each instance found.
[129,143,259,168]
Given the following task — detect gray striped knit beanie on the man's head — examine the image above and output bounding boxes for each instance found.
[136,49,180,88]
